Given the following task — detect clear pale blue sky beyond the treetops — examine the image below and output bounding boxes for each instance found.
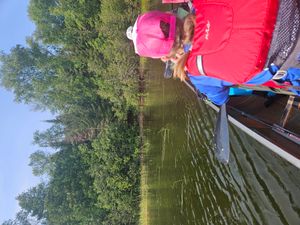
[0,0,51,221]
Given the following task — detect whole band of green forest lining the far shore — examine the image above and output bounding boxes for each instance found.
[0,0,142,225]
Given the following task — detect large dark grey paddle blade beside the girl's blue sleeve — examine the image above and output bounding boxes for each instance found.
[214,104,230,164]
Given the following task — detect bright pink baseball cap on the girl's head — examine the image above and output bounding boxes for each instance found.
[126,11,176,58]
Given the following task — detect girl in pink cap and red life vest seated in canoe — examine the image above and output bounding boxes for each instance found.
[127,0,300,105]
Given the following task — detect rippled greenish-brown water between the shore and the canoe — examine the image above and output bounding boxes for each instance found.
[145,61,300,225]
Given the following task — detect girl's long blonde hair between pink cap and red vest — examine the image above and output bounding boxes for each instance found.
[170,14,196,81]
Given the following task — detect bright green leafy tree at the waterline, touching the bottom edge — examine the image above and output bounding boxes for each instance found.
[81,123,139,224]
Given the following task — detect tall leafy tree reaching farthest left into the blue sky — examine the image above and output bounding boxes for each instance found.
[0,39,102,112]
